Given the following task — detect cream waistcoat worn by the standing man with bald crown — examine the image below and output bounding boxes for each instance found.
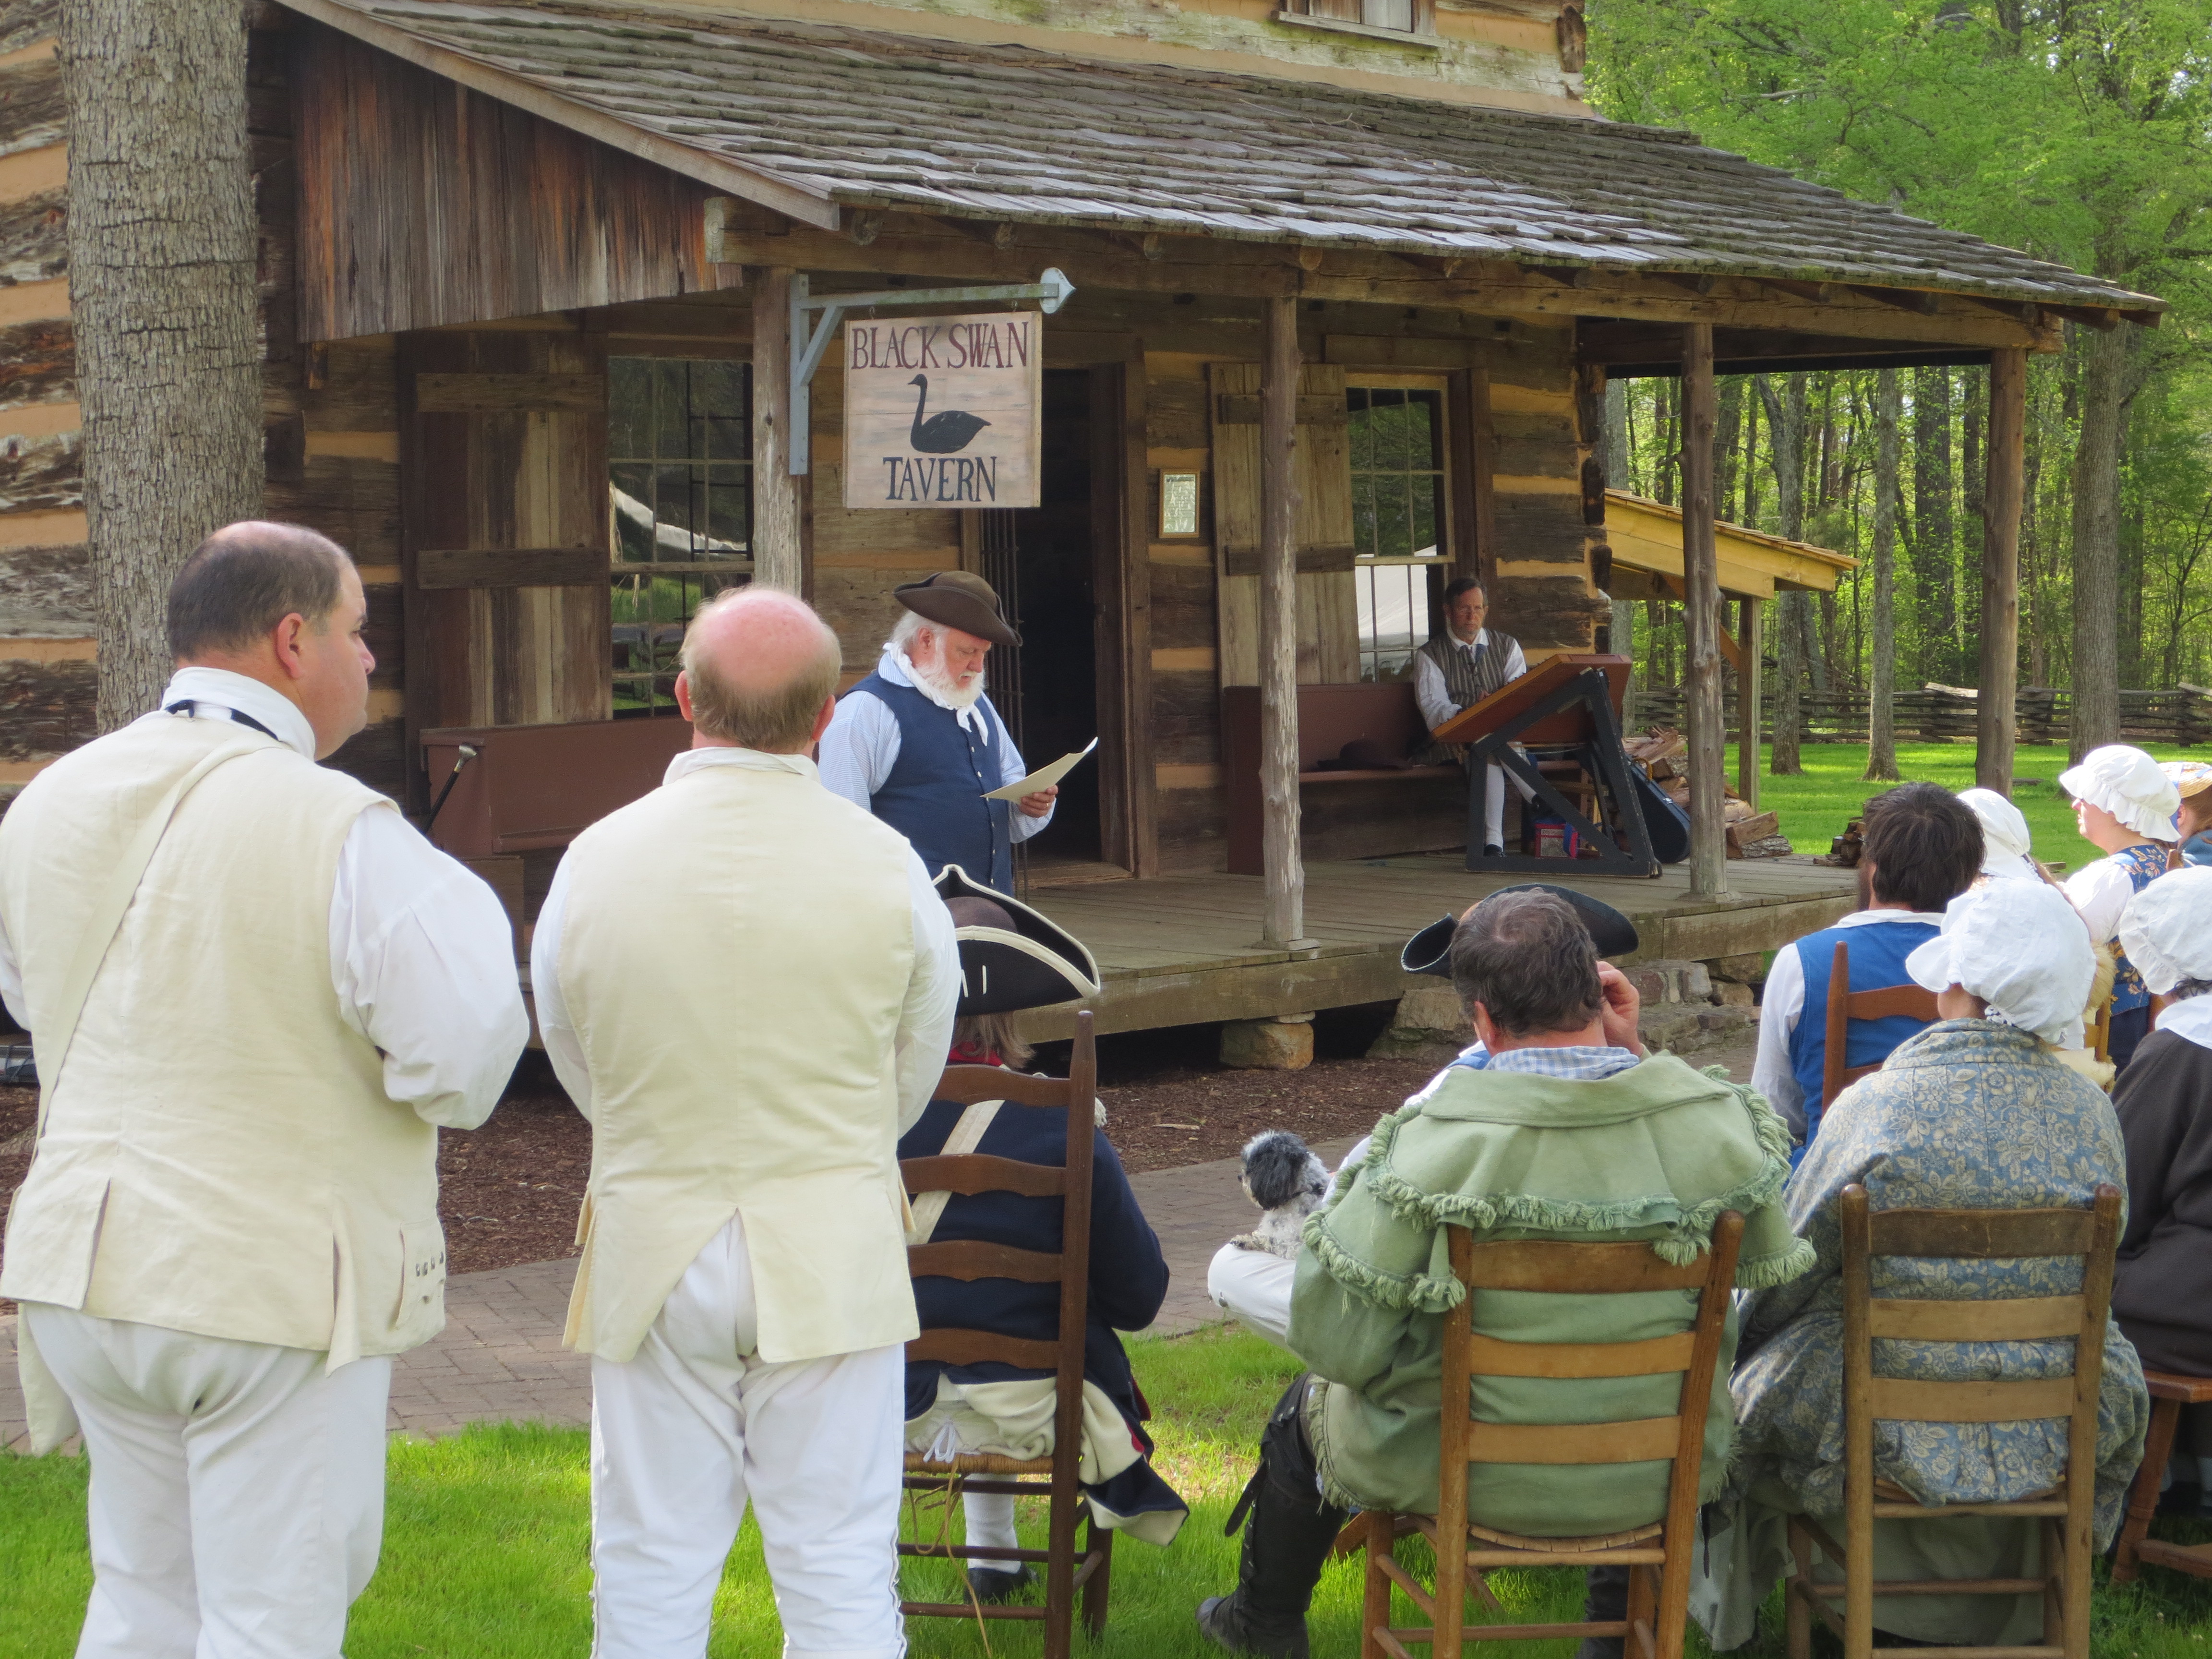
[560,765,920,1360]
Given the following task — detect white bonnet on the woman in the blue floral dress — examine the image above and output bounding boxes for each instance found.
[1904,889,2088,1042]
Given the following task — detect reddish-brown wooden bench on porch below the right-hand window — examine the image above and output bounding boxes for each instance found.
[1221,679,1467,876]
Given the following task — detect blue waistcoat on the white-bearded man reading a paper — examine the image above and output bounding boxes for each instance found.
[845,674,1013,894]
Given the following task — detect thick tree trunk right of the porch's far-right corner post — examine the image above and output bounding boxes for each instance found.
[2066,327,2128,761]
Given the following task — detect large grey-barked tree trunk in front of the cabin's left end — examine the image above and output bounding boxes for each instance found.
[60,0,263,730]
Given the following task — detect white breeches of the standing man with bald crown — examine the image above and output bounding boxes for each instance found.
[590,1216,907,1659]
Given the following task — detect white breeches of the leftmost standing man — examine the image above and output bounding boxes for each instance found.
[22,1303,392,1659]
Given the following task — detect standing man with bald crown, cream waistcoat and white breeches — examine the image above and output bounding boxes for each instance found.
[531,589,960,1659]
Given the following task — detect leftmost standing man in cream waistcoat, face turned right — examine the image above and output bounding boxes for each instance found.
[0,524,529,1659]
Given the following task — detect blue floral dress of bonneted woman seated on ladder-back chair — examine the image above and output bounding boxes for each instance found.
[1701,1020,2150,1648]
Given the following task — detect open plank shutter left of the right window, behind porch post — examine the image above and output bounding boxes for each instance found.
[1210,363,1360,685]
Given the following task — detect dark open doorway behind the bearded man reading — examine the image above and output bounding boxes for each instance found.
[1011,370,1102,878]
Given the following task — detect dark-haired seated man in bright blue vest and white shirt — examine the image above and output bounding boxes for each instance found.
[1752,783,1984,1157]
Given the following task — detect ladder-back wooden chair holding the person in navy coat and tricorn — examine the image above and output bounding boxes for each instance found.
[898,1009,1113,1659]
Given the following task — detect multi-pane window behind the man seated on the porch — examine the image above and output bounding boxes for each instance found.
[1345,385,1449,681]
